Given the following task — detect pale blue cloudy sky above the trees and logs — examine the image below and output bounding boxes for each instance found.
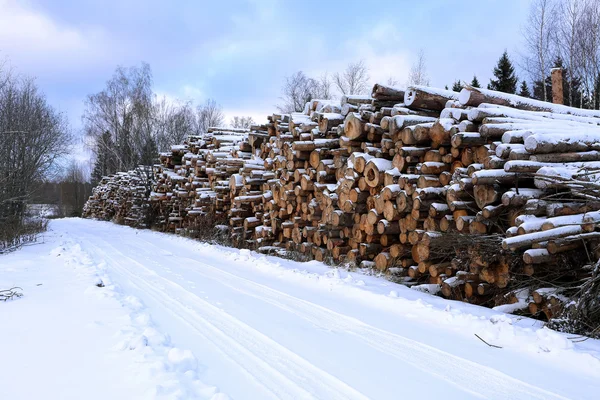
[0,0,529,129]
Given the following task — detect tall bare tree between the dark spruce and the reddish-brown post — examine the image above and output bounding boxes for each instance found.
[524,0,556,100]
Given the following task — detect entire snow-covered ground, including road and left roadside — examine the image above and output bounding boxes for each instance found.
[0,219,600,400]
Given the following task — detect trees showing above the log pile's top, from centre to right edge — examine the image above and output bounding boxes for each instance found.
[278,0,600,113]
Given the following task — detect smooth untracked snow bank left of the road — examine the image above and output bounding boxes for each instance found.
[0,228,229,400]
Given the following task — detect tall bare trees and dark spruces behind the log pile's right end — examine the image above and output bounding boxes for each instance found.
[446,0,600,109]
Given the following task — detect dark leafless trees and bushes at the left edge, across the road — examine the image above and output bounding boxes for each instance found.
[0,63,71,253]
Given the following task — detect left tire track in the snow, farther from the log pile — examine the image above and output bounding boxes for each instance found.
[80,237,367,400]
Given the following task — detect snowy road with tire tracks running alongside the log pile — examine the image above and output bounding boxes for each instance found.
[0,219,600,399]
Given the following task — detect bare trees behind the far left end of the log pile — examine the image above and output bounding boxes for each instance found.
[83,63,254,183]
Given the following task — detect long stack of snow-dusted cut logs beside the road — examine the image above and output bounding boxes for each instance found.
[86,85,600,324]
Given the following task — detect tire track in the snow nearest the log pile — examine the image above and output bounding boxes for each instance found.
[115,234,568,400]
